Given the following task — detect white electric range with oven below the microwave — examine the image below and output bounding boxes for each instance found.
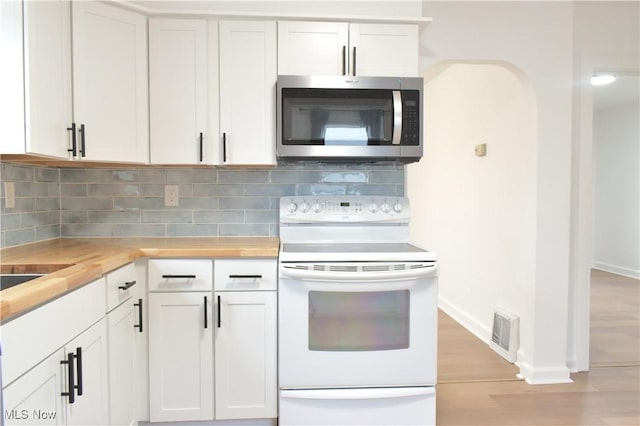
[278,196,438,425]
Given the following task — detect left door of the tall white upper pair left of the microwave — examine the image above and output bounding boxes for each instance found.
[149,19,208,164]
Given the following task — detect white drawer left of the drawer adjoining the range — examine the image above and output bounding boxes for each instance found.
[148,259,213,291]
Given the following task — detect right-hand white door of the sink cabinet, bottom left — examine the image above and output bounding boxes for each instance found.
[65,318,109,425]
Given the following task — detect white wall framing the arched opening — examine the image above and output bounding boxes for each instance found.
[416,1,573,383]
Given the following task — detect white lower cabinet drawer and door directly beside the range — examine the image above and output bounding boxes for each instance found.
[214,259,278,420]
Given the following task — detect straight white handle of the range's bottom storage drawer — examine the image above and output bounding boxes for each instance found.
[280,386,435,400]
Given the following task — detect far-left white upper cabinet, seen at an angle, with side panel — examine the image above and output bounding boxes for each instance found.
[0,1,72,158]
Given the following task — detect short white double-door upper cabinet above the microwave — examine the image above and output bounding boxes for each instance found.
[278,21,418,77]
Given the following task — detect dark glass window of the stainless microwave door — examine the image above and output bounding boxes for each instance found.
[282,88,394,146]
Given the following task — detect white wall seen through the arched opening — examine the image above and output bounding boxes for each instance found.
[408,64,536,342]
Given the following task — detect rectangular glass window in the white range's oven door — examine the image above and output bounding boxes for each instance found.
[309,290,410,351]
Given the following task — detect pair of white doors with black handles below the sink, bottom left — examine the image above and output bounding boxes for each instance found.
[3,318,109,425]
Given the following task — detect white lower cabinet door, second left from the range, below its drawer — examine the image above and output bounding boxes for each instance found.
[149,292,214,422]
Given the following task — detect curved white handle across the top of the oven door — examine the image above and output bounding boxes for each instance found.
[280,264,438,283]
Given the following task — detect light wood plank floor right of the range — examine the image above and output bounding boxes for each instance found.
[436,271,640,426]
